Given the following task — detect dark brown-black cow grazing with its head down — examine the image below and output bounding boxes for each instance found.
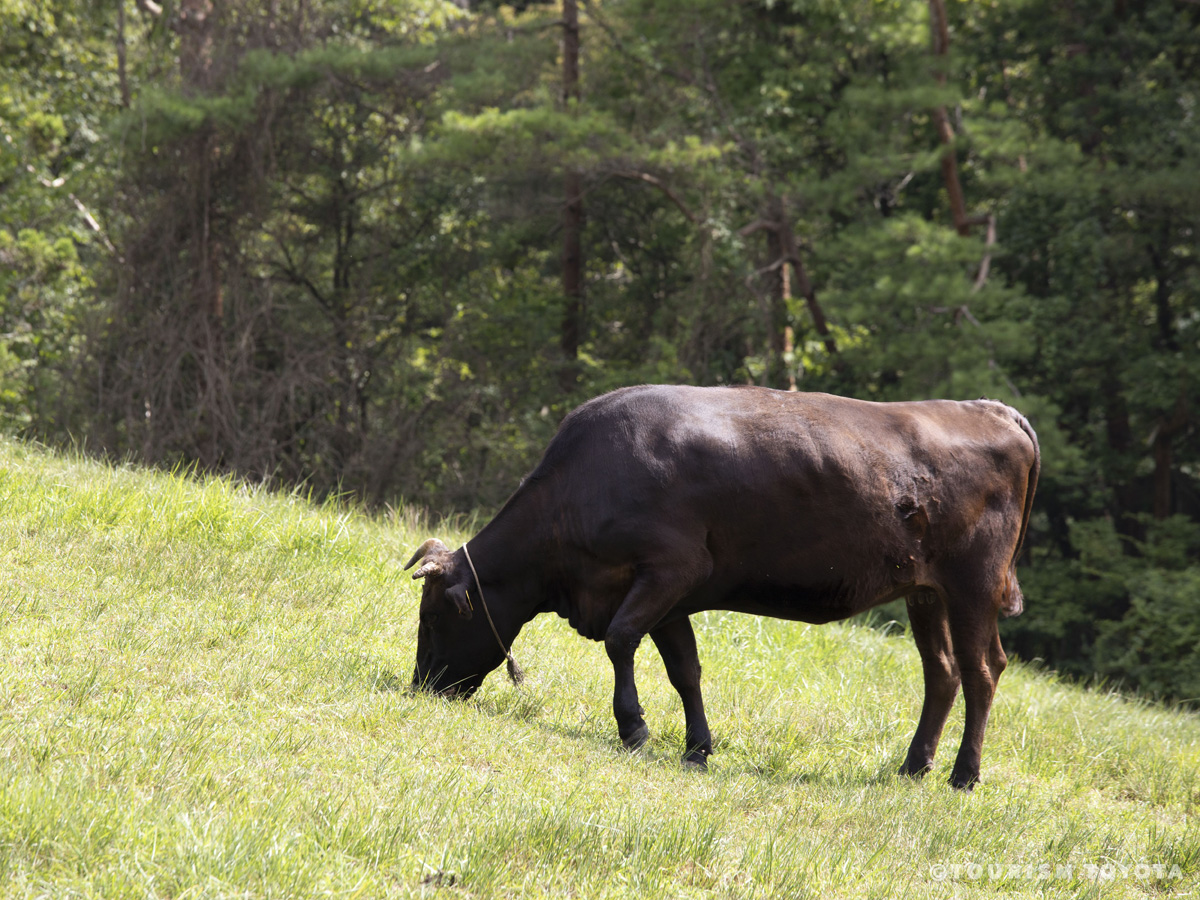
[406,386,1040,790]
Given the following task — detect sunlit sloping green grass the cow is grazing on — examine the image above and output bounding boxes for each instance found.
[0,443,1200,898]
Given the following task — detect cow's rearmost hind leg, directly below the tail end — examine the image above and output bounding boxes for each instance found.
[947,590,1008,791]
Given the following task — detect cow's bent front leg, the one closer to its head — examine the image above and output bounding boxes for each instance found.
[604,542,713,750]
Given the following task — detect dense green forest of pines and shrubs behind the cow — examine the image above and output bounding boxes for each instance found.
[0,0,1200,704]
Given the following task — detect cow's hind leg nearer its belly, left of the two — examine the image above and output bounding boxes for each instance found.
[900,590,959,778]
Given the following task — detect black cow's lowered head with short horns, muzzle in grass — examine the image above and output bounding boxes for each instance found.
[404,538,504,697]
